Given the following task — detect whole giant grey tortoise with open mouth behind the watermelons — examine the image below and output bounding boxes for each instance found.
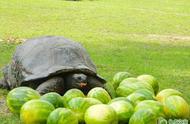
[0,36,106,94]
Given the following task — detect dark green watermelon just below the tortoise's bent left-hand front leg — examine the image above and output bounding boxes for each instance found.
[40,92,63,108]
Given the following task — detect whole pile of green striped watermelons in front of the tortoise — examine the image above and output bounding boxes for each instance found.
[7,72,190,124]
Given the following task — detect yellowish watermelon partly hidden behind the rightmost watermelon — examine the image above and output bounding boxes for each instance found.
[156,89,183,103]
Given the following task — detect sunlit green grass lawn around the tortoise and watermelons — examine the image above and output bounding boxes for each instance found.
[0,0,190,124]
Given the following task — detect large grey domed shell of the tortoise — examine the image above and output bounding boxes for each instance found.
[4,36,105,87]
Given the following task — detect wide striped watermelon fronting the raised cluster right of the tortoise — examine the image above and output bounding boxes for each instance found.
[116,81,154,97]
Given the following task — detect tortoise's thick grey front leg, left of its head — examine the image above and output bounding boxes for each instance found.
[36,77,64,94]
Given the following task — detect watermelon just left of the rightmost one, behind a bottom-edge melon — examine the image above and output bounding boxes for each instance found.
[135,100,164,117]
